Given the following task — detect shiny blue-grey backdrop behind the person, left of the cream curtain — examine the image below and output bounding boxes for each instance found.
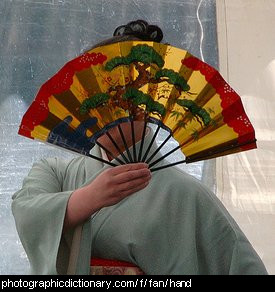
[0,0,218,274]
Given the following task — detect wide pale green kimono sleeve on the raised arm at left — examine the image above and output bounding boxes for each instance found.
[12,159,73,274]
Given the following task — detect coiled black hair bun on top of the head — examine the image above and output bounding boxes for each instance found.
[113,19,163,42]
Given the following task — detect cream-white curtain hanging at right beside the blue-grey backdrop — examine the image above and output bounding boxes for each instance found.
[216,0,275,274]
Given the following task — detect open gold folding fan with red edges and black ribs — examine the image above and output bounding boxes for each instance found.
[19,41,256,171]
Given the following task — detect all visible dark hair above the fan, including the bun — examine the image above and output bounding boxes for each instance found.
[91,19,163,49]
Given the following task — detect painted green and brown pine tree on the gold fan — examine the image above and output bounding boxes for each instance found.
[80,44,211,131]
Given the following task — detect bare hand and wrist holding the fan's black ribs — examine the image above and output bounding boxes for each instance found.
[64,163,151,230]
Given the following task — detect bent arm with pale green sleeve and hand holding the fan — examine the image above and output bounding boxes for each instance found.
[12,160,151,274]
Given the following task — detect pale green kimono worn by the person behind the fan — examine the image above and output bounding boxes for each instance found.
[12,134,267,275]
